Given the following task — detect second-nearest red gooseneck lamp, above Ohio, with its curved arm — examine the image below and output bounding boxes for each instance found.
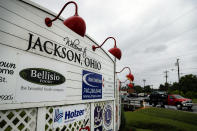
[92,37,122,60]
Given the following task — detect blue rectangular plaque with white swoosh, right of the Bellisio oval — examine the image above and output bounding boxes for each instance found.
[82,70,102,100]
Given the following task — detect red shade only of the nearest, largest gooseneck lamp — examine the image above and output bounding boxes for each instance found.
[64,15,86,37]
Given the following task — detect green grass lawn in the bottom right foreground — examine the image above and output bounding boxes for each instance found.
[122,108,197,131]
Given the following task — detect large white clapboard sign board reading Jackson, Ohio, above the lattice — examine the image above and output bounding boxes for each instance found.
[0,0,115,110]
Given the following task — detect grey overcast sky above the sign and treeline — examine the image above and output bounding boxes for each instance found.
[32,0,197,88]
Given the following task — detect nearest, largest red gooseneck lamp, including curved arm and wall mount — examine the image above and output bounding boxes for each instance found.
[45,1,86,37]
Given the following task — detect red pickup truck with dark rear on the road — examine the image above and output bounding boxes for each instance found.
[149,92,193,110]
